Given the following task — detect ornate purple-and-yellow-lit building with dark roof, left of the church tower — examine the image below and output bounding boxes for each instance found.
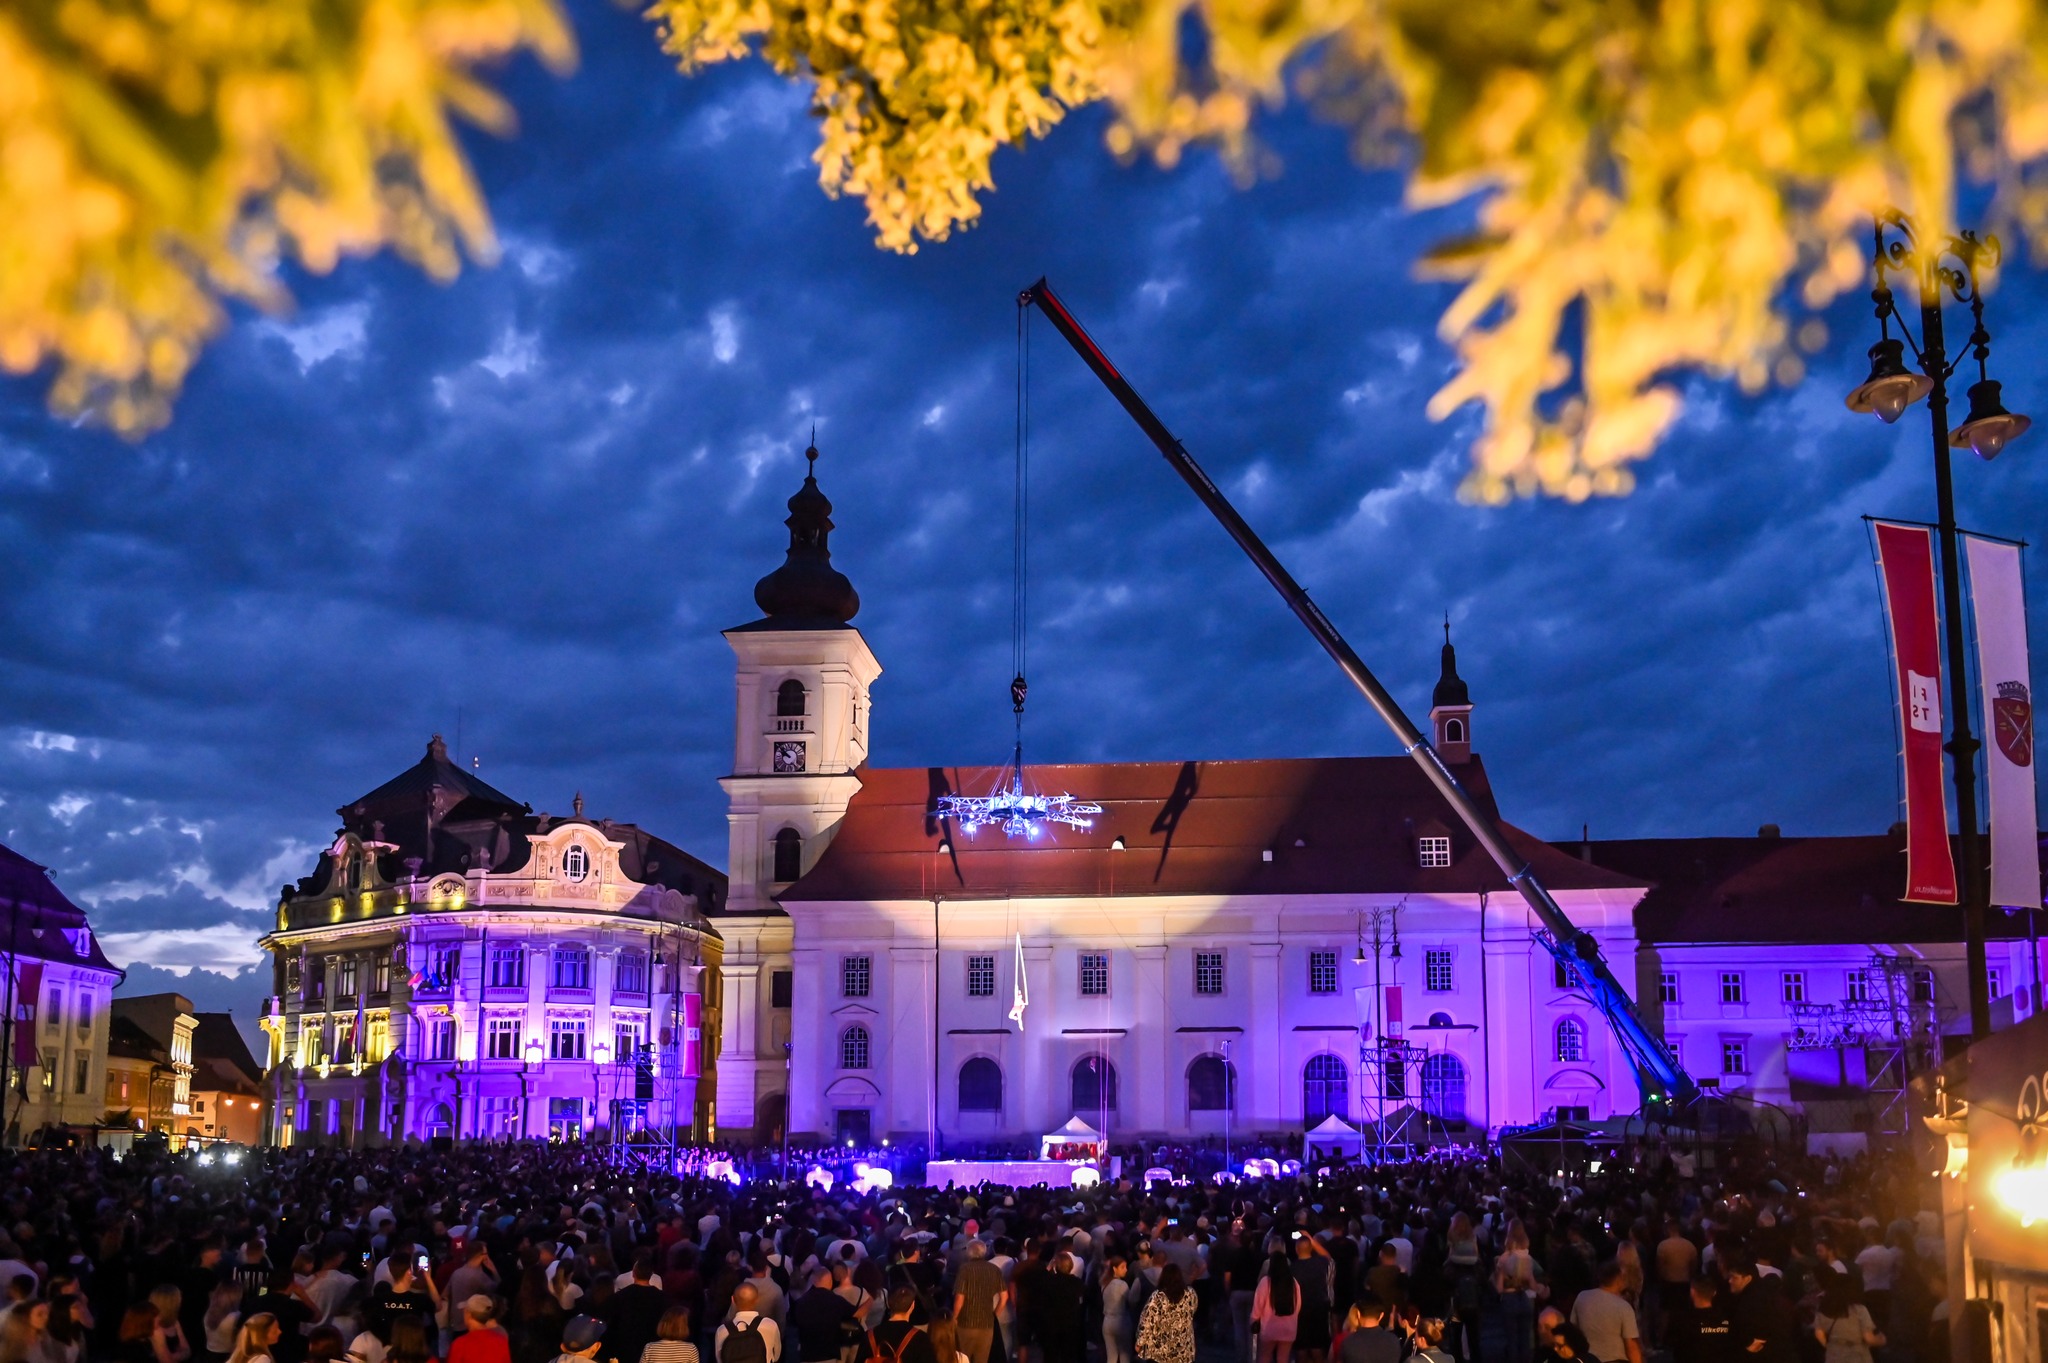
[262,749,725,1146]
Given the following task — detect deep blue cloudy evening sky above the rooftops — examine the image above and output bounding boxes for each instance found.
[0,2,2048,1019]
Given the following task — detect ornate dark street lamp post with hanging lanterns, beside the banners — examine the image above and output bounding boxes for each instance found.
[1847,211,2032,1042]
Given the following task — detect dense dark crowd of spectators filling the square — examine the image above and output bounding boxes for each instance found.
[0,1144,1948,1363]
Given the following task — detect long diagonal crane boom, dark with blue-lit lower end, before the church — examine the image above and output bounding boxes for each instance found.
[1018,278,1700,1111]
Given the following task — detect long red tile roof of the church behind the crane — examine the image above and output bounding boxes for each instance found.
[778,757,1645,903]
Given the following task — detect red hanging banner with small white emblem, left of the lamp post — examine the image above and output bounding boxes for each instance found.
[1876,520,1956,905]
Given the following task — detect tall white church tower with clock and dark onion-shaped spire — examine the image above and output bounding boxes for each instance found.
[717,446,883,1140]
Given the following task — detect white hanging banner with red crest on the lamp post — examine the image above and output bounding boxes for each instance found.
[1964,534,2042,909]
